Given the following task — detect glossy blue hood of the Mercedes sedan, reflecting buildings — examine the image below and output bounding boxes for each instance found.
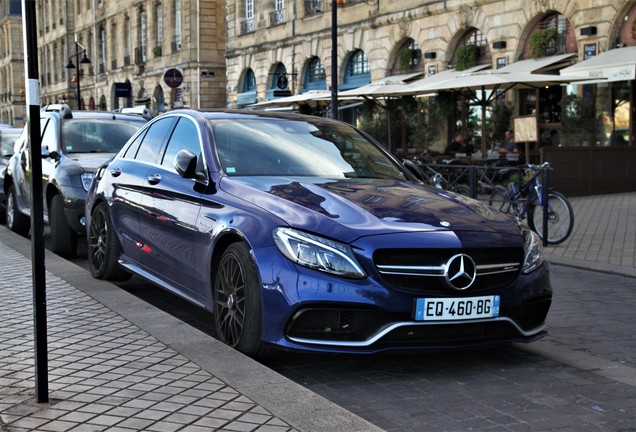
[220,177,519,241]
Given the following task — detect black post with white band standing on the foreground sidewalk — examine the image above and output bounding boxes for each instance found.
[22,0,49,403]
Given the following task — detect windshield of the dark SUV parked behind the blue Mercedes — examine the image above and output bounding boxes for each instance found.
[61,119,144,153]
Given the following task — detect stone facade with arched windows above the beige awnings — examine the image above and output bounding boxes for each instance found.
[227,0,635,106]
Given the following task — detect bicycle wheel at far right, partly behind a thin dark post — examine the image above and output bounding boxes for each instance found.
[528,191,574,244]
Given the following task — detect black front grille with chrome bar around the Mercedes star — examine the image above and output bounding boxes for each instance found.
[373,248,523,295]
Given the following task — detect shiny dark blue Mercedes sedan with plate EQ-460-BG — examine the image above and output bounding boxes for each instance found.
[86,110,552,356]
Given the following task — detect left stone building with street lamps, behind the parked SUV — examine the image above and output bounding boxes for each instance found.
[0,0,226,125]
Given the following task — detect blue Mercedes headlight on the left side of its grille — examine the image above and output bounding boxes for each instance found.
[274,228,366,279]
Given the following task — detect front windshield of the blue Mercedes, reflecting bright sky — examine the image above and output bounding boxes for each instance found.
[212,118,405,180]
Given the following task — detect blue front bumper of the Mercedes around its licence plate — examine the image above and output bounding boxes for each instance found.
[253,241,552,353]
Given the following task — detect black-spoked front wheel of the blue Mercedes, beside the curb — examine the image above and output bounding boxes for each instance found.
[214,243,267,357]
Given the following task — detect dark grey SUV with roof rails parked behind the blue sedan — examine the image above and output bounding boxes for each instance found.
[3,104,150,256]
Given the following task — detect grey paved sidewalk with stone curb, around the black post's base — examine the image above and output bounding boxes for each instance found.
[0,226,379,432]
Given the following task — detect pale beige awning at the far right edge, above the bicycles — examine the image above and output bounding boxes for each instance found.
[561,47,636,84]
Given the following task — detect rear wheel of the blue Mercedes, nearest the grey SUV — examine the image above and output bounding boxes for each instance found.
[88,204,131,281]
